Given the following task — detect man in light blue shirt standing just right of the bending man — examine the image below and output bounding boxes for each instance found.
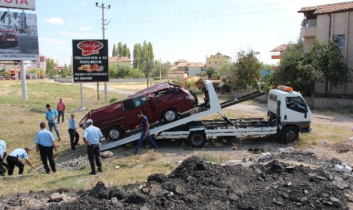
[34,122,58,174]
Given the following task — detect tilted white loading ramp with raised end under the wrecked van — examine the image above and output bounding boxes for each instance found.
[100,80,221,151]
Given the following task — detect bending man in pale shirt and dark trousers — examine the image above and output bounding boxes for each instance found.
[6,148,35,176]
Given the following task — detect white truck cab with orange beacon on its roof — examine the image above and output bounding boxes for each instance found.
[267,85,312,143]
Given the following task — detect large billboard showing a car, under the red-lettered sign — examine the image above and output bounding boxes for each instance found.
[0,11,39,61]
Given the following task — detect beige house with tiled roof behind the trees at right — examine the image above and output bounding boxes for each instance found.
[298,1,353,99]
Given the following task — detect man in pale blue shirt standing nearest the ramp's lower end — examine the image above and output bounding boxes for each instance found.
[83,119,103,175]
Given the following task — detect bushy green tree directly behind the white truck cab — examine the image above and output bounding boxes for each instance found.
[265,39,320,92]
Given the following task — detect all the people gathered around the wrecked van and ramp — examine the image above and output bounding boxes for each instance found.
[0,98,158,176]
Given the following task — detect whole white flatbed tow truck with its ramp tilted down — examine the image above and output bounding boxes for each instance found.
[100,80,312,151]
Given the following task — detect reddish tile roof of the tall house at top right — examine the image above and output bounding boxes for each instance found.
[298,1,353,14]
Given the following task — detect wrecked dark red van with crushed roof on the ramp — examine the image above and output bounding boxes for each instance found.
[80,82,198,141]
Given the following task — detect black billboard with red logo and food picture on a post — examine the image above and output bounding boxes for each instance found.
[72,40,109,82]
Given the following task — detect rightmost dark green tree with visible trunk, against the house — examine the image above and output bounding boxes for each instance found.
[311,39,352,97]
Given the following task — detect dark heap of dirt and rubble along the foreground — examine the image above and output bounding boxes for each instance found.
[0,153,353,210]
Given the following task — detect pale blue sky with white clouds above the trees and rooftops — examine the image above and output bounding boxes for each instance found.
[8,0,344,65]
